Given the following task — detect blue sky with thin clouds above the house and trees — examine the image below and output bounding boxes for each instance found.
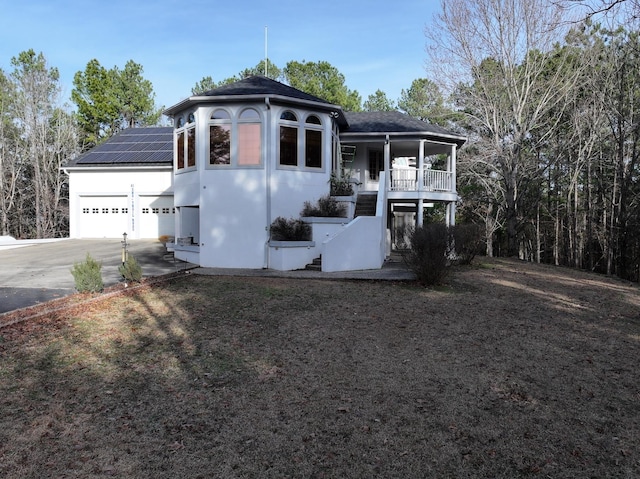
[0,0,440,113]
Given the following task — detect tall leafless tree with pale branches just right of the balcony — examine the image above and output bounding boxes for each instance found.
[426,0,577,255]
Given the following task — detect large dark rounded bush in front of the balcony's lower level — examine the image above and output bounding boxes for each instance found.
[402,223,451,286]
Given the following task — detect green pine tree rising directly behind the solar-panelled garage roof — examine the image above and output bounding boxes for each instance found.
[71,59,162,147]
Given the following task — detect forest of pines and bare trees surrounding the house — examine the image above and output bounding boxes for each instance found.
[0,0,640,281]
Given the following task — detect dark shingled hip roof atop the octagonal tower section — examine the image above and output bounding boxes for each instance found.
[163,75,346,126]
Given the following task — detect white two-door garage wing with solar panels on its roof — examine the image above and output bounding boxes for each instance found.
[63,127,175,239]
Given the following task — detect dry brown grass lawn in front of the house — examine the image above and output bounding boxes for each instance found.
[0,259,640,478]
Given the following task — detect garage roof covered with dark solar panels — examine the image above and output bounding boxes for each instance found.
[66,127,173,167]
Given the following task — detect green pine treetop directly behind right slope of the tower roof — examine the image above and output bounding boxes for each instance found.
[283,60,362,111]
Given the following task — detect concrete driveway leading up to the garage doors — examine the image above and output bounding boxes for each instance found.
[0,237,186,314]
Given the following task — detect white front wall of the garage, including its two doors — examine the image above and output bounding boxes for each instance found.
[68,167,173,239]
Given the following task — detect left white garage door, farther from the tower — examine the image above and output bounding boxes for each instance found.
[79,196,129,238]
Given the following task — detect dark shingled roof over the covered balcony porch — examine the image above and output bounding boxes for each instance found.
[340,111,466,145]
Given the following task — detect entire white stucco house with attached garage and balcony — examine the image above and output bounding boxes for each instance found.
[67,76,465,271]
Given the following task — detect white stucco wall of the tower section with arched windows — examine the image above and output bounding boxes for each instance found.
[175,102,332,269]
